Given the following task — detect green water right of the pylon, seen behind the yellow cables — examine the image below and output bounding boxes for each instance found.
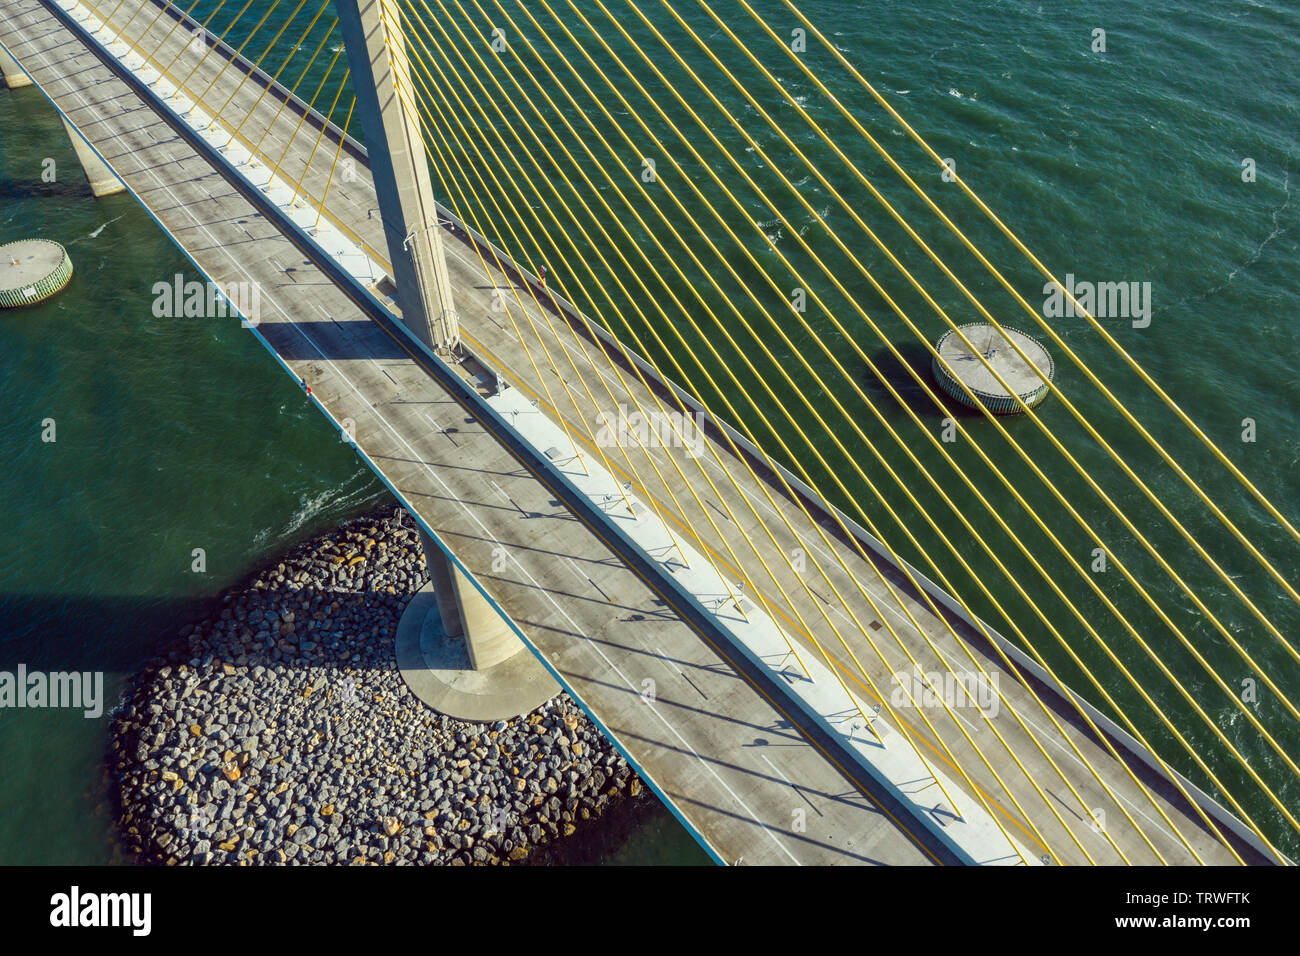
[417,0,1300,848]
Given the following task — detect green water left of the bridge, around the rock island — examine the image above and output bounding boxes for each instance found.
[0,35,707,865]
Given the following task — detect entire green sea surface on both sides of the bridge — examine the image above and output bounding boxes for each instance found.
[0,0,1300,864]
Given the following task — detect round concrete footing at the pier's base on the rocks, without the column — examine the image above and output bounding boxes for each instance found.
[397,584,560,723]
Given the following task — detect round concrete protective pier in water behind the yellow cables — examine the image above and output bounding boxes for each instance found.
[931,323,1054,415]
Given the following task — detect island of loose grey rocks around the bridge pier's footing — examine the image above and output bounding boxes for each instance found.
[111,509,641,865]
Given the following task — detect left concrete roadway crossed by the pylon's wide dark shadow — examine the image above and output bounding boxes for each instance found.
[0,0,967,864]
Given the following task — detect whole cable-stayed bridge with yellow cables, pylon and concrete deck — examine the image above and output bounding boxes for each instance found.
[0,0,1300,865]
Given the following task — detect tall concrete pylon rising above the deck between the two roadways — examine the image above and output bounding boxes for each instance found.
[335,0,460,352]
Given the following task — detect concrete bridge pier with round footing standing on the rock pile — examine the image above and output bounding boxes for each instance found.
[397,531,560,723]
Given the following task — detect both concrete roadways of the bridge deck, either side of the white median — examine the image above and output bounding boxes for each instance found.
[0,0,1258,864]
